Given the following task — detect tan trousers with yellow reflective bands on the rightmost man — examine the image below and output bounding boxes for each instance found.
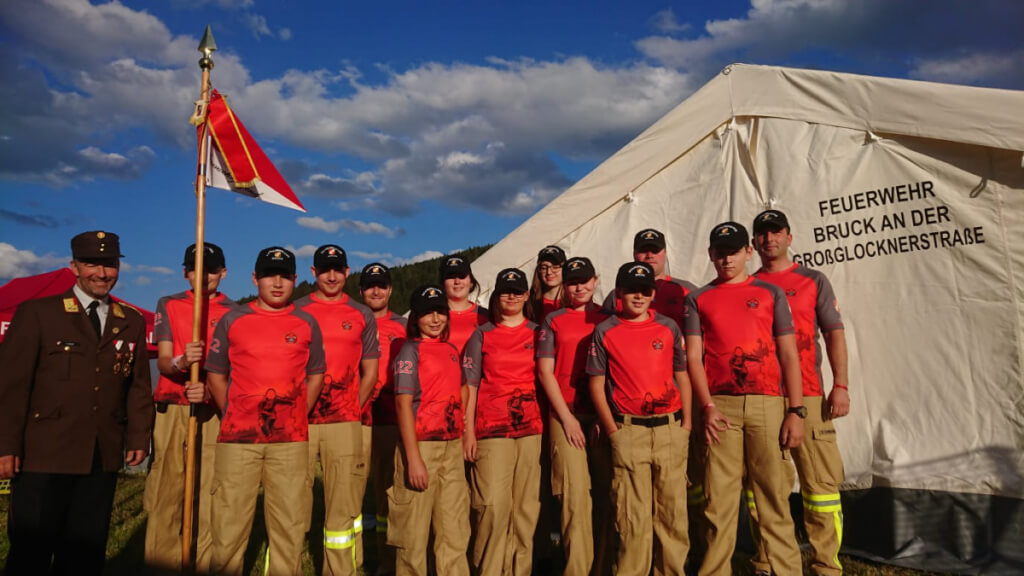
[745,396,845,576]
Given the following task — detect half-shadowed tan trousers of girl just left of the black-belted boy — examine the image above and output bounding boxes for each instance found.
[549,415,615,576]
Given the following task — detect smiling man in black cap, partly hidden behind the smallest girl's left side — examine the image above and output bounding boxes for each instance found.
[359,262,405,574]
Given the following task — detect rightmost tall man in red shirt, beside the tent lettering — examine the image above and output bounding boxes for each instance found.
[754,210,850,576]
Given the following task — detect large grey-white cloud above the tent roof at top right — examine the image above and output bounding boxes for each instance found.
[636,0,1024,79]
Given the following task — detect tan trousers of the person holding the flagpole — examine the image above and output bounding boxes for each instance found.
[142,404,220,574]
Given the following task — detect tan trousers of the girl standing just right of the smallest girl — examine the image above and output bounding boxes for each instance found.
[469,435,542,576]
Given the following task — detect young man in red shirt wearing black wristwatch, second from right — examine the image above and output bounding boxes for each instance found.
[684,222,807,575]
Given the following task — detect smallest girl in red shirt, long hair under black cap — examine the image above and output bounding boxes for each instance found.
[387,286,469,576]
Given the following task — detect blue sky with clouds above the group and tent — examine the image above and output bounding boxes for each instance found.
[0,0,1024,308]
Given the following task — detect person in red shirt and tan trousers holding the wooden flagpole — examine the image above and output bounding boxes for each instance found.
[142,242,237,574]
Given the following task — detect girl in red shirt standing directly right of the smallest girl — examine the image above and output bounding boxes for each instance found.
[463,269,544,576]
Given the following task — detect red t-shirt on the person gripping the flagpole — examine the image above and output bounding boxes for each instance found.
[153,290,238,406]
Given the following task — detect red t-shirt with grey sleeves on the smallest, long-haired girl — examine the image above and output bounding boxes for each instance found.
[394,338,463,441]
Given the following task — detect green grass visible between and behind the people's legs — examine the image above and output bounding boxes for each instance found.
[0,474,934,576]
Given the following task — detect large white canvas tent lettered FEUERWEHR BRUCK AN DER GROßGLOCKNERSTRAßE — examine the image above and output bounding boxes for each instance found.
[473,65,1024,571]
